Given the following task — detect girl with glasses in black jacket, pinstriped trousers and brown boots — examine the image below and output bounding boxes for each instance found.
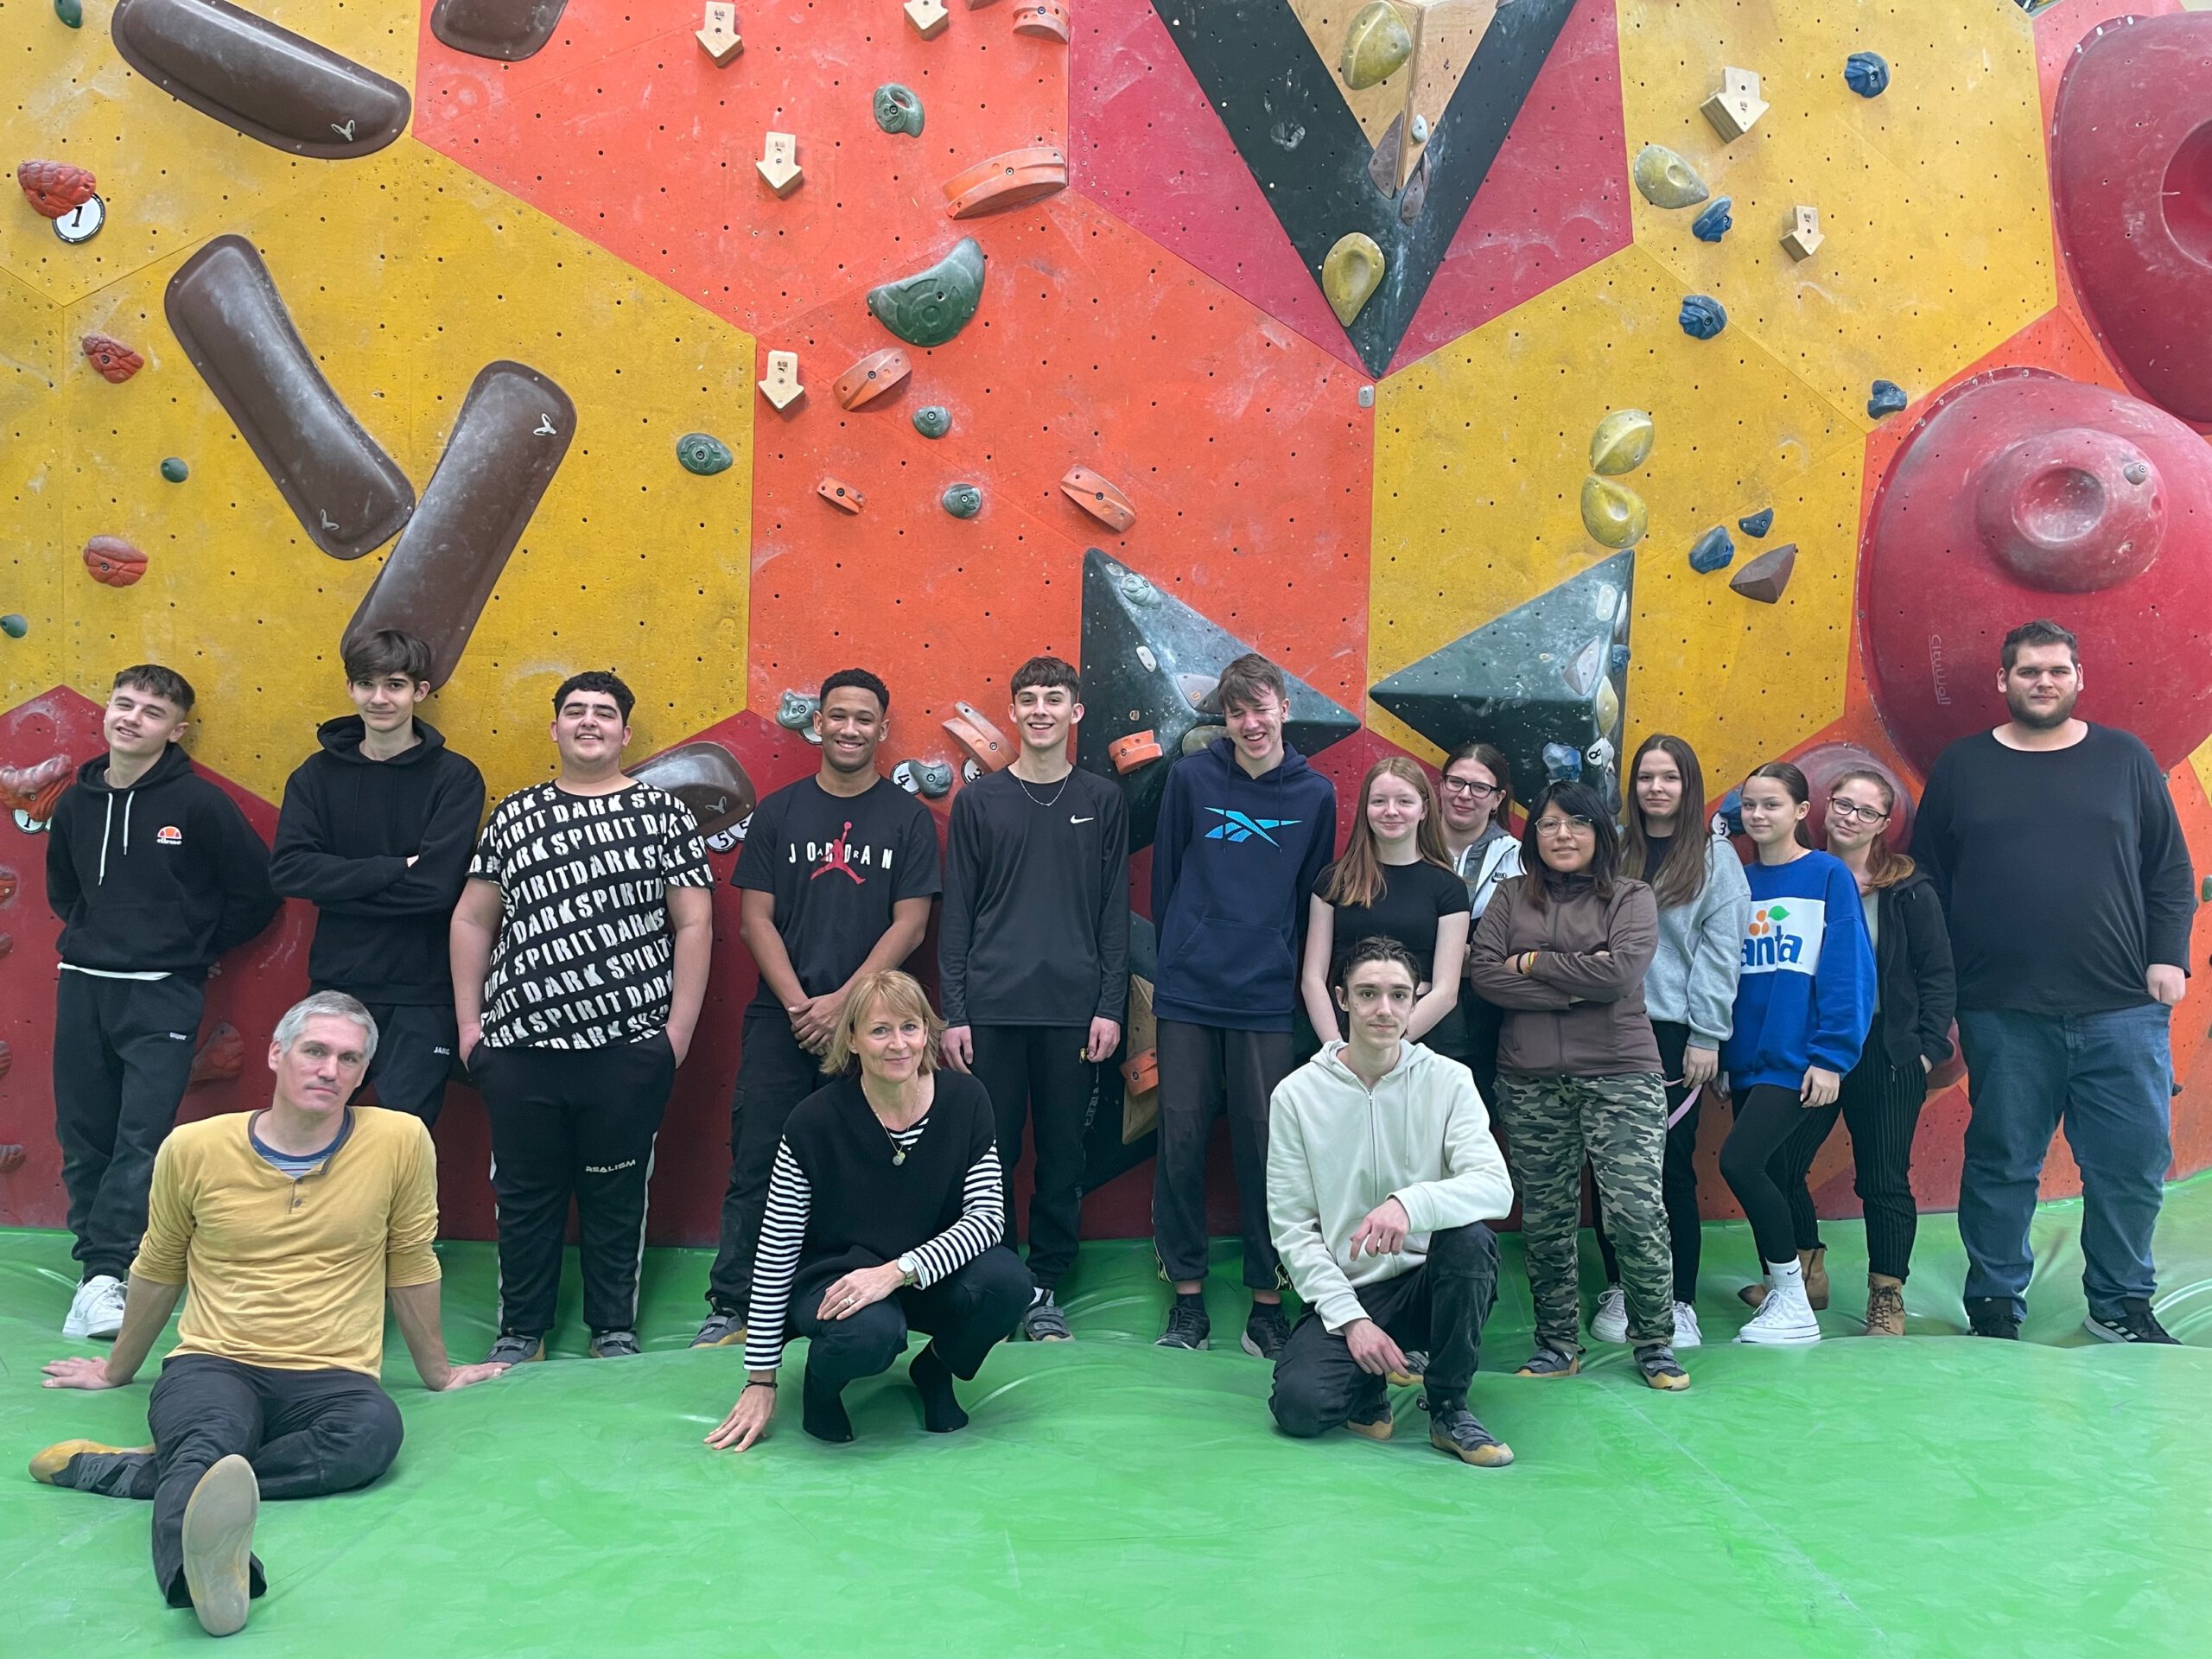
[1745,770,1958,1336]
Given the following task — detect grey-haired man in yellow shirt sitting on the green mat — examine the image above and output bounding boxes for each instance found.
[31,991,506,1637]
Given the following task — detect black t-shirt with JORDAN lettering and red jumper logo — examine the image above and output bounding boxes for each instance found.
[730,779,938,1011]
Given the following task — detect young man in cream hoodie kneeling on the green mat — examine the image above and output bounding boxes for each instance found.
[1268,938,1513,1469]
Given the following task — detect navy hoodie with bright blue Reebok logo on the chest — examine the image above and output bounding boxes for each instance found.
[1153,736,1336,1031]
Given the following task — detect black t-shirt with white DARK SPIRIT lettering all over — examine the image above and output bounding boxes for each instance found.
[469,783,715,1048]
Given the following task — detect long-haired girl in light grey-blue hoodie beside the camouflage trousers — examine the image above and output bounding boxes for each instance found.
[1591,732,1752,1350]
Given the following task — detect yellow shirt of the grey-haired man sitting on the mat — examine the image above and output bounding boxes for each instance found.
[130,1106,438,1376]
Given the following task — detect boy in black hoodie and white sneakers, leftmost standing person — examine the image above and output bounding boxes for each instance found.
[47,664,279,1338]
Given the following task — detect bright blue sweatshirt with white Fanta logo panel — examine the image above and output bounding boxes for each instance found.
[1721,852,1873,1097]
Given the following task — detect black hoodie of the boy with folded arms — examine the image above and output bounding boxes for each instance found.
[270,715,485,1007]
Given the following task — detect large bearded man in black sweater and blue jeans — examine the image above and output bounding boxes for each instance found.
[1913,621,2196,1343]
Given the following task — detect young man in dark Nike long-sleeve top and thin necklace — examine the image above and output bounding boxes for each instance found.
[938,657,1128,1343]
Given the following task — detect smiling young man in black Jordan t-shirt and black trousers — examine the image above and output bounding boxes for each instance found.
[692,668,938,1347]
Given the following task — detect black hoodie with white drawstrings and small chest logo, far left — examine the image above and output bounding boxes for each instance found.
[47,743,279,982]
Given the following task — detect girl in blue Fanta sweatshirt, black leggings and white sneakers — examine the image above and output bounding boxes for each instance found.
[1721,761,1873,1343]
